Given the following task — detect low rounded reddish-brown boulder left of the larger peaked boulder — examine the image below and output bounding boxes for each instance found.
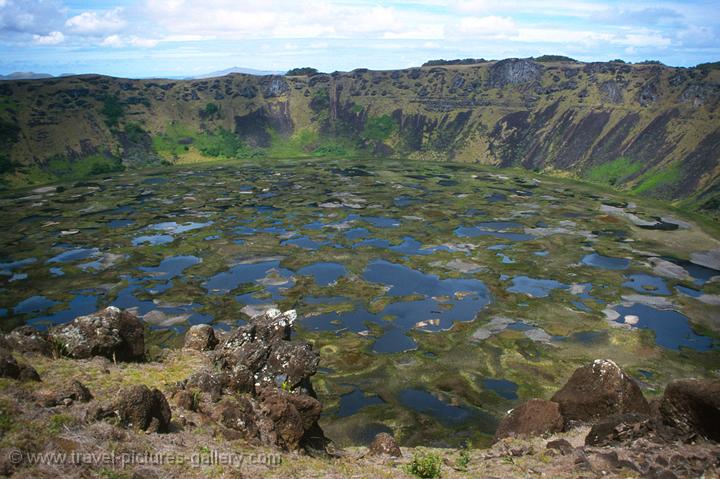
[495,399,563,441]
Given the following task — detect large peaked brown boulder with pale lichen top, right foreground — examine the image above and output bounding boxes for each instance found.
[552,359,650,425]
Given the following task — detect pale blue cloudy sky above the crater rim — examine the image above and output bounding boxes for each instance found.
[0,0,720,78]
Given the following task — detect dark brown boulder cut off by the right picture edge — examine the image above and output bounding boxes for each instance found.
[659,379,720,442]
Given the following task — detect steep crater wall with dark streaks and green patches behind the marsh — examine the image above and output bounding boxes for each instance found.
[0,59,720,208]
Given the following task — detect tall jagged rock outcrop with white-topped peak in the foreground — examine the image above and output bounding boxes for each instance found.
[174,310,327,451]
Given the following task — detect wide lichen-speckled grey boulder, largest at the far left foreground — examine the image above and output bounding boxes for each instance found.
[49,306,145,361]
